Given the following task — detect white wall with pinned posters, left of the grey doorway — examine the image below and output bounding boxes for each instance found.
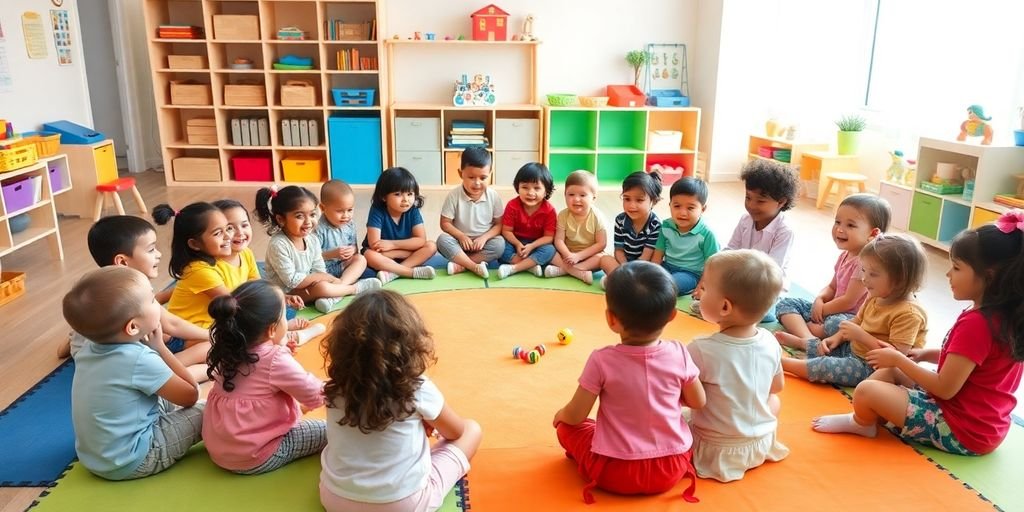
[0,0,92,132]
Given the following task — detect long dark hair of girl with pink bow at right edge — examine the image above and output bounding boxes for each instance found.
[949,210,1024,361]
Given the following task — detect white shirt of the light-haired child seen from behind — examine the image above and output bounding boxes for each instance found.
[686,329,782,437]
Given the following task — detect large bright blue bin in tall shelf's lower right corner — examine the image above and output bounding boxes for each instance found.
[327,113,384,185]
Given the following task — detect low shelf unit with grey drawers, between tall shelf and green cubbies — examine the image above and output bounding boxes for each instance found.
[390,103,542,186]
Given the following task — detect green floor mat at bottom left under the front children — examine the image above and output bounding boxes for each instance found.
[33,444,465,512]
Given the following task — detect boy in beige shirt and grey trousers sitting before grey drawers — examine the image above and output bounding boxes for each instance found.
[437,147,505,279]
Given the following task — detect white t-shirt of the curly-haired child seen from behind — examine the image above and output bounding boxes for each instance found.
[321,376,444,503]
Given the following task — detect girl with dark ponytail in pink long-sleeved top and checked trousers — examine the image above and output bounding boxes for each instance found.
[203,280,327,475]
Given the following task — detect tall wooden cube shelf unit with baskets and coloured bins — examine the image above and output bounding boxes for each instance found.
[144,0,387,186]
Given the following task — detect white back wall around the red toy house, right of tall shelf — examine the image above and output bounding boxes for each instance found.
[381,0,700,106]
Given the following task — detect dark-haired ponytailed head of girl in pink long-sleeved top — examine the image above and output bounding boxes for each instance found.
[206,280,285,391]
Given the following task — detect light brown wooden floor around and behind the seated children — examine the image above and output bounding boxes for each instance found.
[0,171,983,511]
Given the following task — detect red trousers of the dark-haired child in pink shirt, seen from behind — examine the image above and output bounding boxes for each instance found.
[557,420,698,504]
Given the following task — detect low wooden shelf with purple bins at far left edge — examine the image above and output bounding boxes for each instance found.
[0,154,72,259]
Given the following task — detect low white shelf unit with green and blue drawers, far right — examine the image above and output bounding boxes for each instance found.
[901,137,1024,251]
